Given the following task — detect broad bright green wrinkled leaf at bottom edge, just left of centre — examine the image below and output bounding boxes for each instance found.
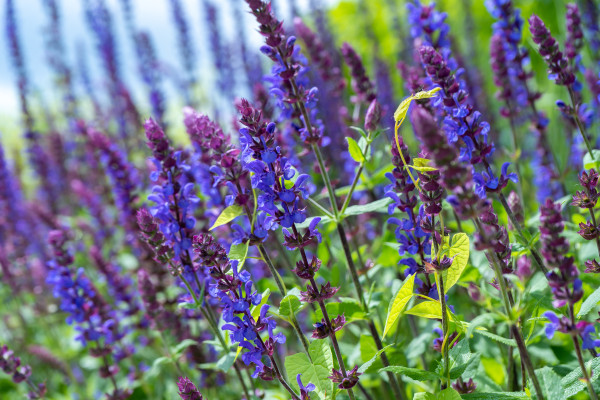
[284,340,333,399]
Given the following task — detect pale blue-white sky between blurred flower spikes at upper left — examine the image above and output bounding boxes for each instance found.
[0,0,336,136]
